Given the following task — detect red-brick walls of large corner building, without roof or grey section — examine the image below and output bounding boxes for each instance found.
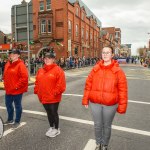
[31,0,100,58]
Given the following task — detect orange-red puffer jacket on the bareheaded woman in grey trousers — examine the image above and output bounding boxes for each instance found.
[82,60,128,113]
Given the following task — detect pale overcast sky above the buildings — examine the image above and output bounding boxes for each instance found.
[0,0,150,55]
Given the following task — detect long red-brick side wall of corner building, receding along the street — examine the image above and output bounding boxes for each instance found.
[68,2,100,57]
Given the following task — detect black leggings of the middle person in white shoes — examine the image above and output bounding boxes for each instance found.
[43,102,59,129]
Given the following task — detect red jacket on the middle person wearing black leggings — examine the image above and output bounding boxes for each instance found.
[34,64,66,104]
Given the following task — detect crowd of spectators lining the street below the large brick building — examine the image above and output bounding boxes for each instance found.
[0,56,99,77]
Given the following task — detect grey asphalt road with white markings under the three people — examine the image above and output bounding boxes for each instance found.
[0,65,150,150]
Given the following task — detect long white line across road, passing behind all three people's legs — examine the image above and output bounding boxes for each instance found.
[0,106,150,136]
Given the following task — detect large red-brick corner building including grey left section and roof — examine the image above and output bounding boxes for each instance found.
[12,0,101,58]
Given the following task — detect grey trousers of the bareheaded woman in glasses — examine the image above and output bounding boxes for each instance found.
[90,103,118,145]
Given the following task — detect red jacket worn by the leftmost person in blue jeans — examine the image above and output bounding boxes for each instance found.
[3,59,28,95]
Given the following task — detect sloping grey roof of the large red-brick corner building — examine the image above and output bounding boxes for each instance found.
[68,0,102,27]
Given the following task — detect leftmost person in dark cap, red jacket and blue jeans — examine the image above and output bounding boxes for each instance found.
[3,49,28,126]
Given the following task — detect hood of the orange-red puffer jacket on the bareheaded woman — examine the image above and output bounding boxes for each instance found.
[93,59,120,73]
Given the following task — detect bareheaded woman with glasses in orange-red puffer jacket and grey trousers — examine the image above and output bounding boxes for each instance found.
[82,46,128,150]
